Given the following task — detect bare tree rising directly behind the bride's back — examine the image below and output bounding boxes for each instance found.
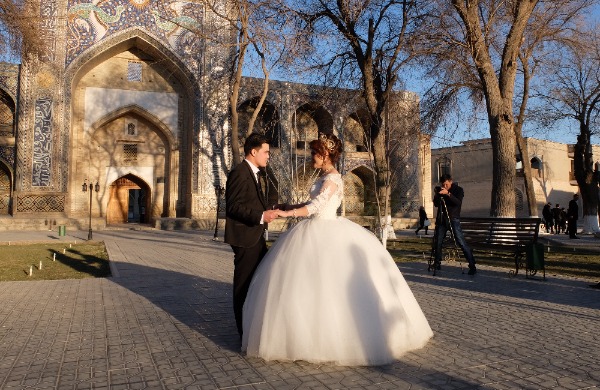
[292,0,426,235]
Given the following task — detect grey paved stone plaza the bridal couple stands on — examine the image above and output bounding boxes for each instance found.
[0,230,600,390]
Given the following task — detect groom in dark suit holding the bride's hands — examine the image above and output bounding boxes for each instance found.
[225,133,278,338]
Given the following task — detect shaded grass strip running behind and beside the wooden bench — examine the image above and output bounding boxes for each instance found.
[388,237,600,279]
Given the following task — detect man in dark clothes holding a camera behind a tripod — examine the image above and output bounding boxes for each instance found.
[433,174,477,275]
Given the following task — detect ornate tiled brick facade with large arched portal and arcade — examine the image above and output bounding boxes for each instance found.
[0,0,429,227]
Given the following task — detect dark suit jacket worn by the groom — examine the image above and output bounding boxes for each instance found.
[225,160,267,248]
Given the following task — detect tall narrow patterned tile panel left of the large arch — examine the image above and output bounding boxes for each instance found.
[31,98,52,187]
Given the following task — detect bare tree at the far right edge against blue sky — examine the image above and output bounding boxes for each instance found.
[539,26,600,232]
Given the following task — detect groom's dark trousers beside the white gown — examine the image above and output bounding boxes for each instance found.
[231,236,267,337]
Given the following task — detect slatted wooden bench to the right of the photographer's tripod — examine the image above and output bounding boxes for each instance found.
[460,217,546,279]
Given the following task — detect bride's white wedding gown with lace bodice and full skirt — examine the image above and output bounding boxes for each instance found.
[242,173,433,365]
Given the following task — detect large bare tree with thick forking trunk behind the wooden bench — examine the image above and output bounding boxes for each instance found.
[424,0,590,216]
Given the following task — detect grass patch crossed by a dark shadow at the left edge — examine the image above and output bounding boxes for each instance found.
[0,242,110,281]
